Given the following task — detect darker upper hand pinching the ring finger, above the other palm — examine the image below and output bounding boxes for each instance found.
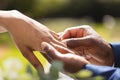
[61,25,113,66]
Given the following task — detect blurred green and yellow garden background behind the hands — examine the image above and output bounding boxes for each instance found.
[0,0,120,79]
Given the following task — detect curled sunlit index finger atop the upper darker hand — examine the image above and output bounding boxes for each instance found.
[60,25,94,39]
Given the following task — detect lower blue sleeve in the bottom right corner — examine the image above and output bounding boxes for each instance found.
[84,64,120,80]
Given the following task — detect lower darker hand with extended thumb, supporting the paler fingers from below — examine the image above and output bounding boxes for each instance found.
[41,42,88,72]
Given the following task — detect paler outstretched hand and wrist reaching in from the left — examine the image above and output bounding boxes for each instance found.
[0,10,63,70]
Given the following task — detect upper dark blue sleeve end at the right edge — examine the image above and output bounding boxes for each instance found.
[111,43,120,67]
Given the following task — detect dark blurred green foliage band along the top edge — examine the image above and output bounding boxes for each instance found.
[0,0,120,19]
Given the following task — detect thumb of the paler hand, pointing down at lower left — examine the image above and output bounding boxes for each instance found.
[19,46,44,71]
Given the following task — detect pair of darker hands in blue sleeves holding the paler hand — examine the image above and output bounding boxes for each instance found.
[41,25,113,73]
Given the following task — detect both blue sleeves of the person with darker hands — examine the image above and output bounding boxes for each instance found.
[84,43,120,80]
